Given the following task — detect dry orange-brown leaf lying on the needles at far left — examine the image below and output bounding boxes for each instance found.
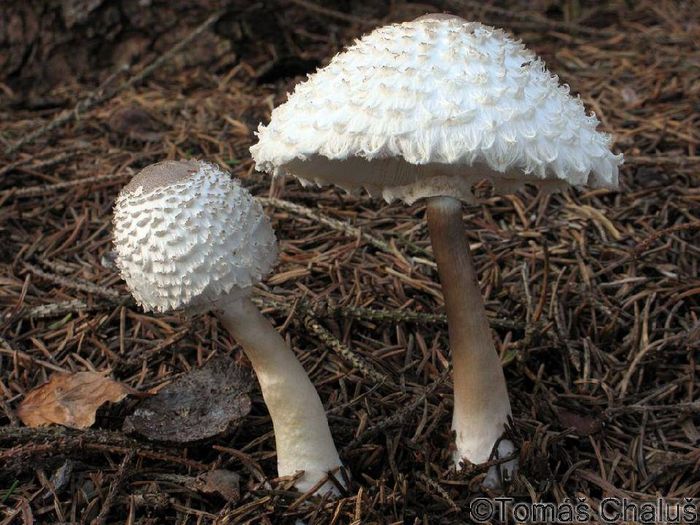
[17,372,131,428]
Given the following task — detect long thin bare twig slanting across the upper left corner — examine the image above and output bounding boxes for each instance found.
[5,9,225,155]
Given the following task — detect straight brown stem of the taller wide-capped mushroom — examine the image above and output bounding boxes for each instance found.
[427,197,515,486]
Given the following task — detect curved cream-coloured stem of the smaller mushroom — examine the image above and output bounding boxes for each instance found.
[218,297,342,492]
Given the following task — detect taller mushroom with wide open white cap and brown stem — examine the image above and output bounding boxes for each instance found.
[251,15,622,486]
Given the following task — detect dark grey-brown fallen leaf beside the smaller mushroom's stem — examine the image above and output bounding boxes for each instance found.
[123,358,253,443]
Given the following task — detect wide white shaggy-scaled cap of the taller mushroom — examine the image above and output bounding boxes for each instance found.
[250,15,622,204]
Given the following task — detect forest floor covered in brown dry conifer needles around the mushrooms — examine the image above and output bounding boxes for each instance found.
[0,0,700,524]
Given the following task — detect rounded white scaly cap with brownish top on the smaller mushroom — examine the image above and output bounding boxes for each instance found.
[113,161,277,312]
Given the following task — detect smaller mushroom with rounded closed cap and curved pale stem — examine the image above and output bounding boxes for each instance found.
[114,161,341,492]
